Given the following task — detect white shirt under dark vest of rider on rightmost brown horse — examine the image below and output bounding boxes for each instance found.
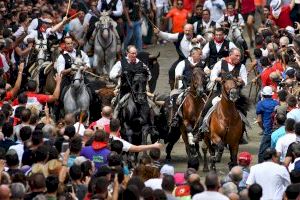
[210,60,248,85]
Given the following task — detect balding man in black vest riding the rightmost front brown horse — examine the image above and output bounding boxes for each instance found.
[199,48,247,142]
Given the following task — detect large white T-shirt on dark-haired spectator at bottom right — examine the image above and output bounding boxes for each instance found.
[246,161,291,200]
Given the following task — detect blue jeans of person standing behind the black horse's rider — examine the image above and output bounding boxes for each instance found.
[124,20,143,52]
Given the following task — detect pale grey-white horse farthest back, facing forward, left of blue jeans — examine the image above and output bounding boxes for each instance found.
[93,12,118,74]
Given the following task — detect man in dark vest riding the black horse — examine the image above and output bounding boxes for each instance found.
[109,45,156,139]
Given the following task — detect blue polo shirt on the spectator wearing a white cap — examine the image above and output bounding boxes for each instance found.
[256,98,279,135]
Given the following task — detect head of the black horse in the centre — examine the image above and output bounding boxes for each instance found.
[132,73,148,103]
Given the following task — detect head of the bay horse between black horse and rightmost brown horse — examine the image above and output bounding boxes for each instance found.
[191,67,206,97]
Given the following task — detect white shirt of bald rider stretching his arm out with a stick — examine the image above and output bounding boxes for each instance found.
[158,31,191,58]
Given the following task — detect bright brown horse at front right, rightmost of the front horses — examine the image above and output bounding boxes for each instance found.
[202,76,243,171]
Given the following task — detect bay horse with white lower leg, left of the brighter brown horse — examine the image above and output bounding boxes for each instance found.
[166,67,206,159]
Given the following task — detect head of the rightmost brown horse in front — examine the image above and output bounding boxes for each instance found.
[222,73,240,102]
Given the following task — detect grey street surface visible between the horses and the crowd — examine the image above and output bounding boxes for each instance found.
[146,43,261,177]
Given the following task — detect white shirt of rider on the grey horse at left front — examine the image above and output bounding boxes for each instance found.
[54,49,91,74]
